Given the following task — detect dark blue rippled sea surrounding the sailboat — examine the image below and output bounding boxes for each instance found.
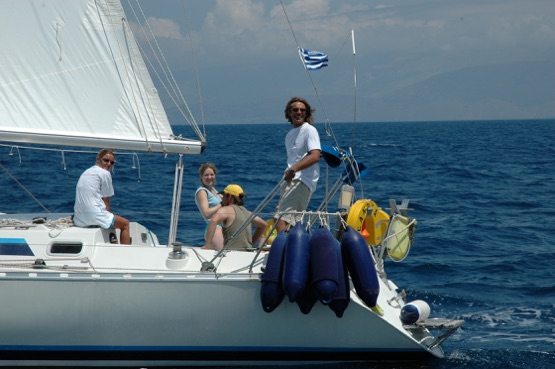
[0,120,555,369]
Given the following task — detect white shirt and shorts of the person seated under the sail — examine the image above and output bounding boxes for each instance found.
[73,165,114,228]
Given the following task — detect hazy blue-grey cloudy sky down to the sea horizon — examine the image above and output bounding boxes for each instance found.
[123,0,555,124]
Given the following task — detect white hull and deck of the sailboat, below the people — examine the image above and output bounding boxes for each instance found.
[0,214,452,366]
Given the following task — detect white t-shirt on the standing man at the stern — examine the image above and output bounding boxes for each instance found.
[285,123,322,192]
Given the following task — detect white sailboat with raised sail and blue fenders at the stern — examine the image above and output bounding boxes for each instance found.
[0,0,462,367]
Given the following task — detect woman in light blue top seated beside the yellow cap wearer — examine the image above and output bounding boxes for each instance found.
[195,163,224,250]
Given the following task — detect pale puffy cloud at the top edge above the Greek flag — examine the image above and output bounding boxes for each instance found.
[197,0,352,62]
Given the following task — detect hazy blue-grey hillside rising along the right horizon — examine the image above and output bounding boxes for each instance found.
[359,62,555,121]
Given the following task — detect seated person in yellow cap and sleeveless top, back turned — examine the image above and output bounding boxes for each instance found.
[205,184,266,250]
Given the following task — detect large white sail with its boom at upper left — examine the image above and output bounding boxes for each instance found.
[0,0,203,154]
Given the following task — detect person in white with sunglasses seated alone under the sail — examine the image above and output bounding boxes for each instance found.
[73,149,131,245]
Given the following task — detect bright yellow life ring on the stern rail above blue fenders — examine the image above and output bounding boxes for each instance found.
[347,199,389,246]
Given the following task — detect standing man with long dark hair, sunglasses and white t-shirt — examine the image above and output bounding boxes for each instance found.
[276,97,322,232]
